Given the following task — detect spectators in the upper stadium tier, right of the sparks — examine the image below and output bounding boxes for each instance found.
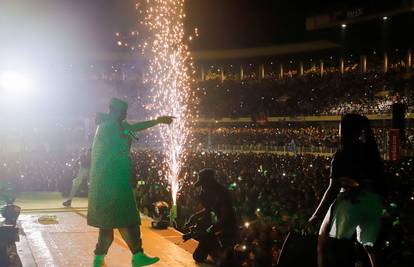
[195,69,414,118]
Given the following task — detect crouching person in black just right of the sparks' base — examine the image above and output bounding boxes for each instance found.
[187,169,238,266]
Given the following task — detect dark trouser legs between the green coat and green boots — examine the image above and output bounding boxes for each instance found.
[95,225,143,255]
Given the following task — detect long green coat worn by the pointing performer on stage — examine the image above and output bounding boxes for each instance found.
[88,116,141,229]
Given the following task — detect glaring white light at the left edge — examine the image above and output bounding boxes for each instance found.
[0,71,34,91]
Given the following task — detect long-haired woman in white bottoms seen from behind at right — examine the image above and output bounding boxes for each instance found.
[308,114,384,267]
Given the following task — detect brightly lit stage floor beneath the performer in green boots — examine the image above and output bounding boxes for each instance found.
[16,194,210,267]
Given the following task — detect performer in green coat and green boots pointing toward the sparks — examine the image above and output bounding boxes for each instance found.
[88,98,173,267]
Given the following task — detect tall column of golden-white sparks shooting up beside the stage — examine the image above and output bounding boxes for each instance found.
[143,0,193,207]
